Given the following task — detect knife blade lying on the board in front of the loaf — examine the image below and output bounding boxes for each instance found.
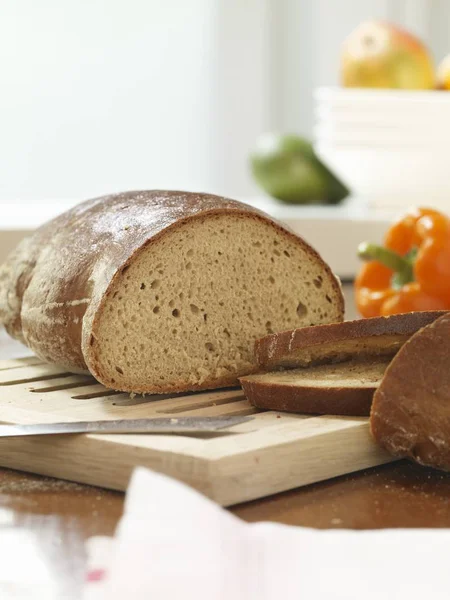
[0,416,253,438]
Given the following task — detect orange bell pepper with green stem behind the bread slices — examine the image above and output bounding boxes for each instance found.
[355,208,450,317]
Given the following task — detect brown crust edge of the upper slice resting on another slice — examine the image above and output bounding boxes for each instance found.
[255,311,446,370]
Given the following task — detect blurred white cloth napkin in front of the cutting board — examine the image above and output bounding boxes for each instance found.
[86,468,450,600]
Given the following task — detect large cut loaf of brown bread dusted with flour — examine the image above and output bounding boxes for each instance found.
[0,191,344,393]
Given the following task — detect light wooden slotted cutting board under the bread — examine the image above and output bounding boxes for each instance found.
[0,357,392,506]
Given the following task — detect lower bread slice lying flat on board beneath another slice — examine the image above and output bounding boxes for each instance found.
[240,356,391,416]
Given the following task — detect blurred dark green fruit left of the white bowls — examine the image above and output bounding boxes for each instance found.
[250,134,349,204]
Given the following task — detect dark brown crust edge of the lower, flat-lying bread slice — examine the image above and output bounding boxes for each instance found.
[240,377,376,417]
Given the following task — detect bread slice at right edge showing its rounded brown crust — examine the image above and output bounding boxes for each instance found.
[370,313,450,471]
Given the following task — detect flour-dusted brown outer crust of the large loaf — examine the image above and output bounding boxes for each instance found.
[0,190,344,391]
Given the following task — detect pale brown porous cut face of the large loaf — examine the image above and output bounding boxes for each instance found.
[91,214,342,392]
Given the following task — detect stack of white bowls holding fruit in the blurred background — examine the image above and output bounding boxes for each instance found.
[314,88,450,210]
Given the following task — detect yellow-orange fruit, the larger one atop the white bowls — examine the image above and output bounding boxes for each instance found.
[341,21,435,90]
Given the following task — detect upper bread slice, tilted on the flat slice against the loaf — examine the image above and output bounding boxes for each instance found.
[255,311,445,371]
